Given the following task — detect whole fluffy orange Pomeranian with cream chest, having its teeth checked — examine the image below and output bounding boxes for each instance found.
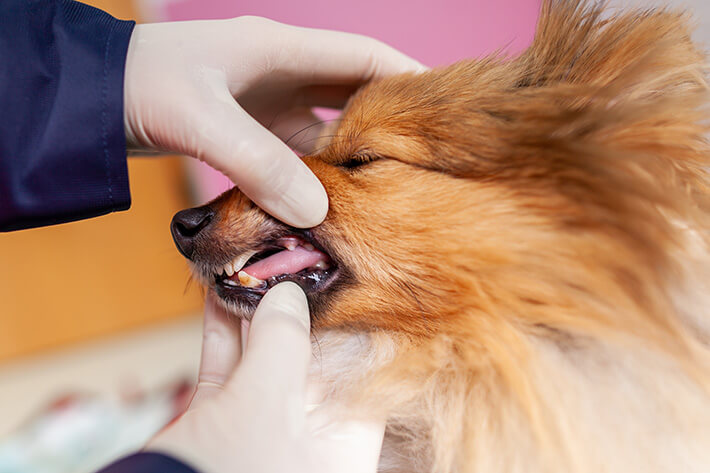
[172,0,710,473]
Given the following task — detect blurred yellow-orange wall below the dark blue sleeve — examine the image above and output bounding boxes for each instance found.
[0,0,201,359]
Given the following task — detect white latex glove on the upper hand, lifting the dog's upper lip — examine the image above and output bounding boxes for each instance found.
[124,17,424,227]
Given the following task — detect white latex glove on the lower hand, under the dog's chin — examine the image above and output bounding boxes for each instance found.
[146,282,384,473]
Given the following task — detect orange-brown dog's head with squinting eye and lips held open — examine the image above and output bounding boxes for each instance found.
[172,1,707,342]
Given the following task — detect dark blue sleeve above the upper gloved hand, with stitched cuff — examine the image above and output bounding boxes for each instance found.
[0,0,135,231]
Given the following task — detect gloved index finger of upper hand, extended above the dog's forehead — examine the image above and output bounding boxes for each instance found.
[273,25,427,83]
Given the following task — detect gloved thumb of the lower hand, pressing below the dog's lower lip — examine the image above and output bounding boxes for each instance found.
[235,282,311,396]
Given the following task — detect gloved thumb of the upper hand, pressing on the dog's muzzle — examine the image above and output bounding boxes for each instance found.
[195,90,328,228]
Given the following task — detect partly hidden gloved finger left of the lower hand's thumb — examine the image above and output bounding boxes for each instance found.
[190,292,242,407]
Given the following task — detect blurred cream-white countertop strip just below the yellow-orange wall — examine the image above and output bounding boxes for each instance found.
[0,316,202,436]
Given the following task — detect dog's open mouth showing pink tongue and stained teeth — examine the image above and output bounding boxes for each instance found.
[213,234,338,305]
